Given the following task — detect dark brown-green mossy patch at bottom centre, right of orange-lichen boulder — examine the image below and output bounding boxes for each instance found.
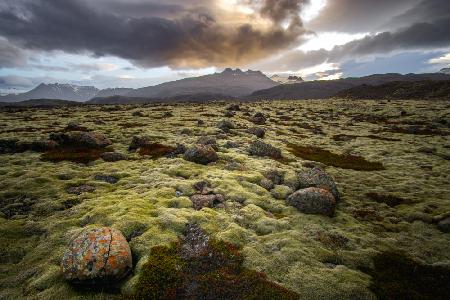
[134,239,299,299]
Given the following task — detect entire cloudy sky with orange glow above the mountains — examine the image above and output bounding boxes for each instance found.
[0,0,450,94]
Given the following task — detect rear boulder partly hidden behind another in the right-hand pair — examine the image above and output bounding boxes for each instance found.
[298,168,340,201]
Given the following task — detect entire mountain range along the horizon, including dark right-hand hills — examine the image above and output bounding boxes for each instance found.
[0,68,450,104]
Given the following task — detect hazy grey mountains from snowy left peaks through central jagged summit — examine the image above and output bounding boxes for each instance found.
[0,68,279,102]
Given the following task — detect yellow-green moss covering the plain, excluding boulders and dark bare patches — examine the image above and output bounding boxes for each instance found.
[0,100,450,299]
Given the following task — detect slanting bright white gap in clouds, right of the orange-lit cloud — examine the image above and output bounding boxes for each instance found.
[297,32,366,51]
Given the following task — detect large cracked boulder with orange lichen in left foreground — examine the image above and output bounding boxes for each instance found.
[61,227,133,283]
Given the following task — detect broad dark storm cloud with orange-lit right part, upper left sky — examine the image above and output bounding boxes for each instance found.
[0,0,305,67]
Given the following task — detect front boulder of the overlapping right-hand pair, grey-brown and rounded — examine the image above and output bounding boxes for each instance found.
[286,187,336,217]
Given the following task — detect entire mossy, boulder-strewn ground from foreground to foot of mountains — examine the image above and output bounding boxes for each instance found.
[0,99,450,299]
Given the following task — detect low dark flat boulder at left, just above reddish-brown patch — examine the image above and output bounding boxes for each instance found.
[50,131,112,149]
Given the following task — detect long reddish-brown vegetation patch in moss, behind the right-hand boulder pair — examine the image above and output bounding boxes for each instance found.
[287,143,385,171]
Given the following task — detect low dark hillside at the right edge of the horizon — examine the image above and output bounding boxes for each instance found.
[336,80,450,100]
